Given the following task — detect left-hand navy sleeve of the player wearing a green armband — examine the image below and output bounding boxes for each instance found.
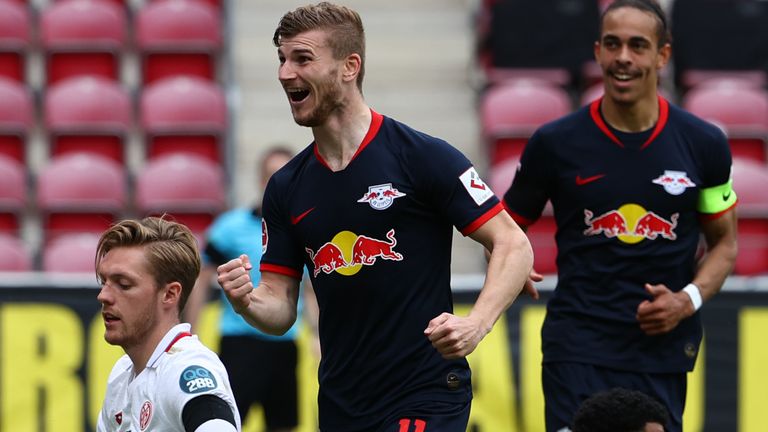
[504,131,554,226]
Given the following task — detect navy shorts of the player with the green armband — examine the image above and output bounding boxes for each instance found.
[541,362,687,432]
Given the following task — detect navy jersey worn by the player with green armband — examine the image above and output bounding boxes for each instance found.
[504,98,735,372]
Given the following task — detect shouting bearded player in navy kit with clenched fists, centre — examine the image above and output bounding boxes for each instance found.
[218,3,532,432]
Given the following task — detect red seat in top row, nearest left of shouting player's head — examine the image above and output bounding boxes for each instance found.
[136,0,222,84]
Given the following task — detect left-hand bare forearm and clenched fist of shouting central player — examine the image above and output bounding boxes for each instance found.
[217,255,299,335]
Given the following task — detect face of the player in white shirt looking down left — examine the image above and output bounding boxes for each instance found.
[96,246,170,354]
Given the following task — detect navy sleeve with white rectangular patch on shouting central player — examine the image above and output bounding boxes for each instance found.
[410,139,503,236]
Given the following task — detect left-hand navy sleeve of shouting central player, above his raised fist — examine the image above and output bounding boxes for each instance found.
[260,175,304,280]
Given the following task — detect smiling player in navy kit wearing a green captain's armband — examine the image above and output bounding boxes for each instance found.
[504,0,737,431]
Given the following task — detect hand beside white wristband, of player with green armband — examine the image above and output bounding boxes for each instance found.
[637,284,694,336]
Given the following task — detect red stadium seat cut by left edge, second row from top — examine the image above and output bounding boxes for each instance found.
[0,77,34,164]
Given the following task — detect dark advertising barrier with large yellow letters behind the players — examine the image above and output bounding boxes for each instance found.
[0,275,768,432]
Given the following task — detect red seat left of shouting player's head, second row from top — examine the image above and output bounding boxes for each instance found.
[141,76,227,163]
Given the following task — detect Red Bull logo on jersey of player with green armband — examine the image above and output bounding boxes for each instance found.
[584,204,680,244]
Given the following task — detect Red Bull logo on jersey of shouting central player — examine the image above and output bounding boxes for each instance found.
[305,229,403,277]
